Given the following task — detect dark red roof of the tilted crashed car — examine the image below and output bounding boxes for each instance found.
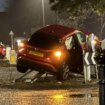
[39,25,79,39]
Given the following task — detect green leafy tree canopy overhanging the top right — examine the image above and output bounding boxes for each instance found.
[50,0,105,17]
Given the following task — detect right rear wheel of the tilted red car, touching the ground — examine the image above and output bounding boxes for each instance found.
[57,62,70,81]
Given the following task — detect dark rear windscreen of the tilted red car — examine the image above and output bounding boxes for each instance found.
[29,32,59,49]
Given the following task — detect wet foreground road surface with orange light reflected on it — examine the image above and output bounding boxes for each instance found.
[0,89,99,105]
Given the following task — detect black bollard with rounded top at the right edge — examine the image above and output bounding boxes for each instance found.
[95,51,105,105]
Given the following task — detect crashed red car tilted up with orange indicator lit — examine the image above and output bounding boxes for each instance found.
[16,25,86,81]
